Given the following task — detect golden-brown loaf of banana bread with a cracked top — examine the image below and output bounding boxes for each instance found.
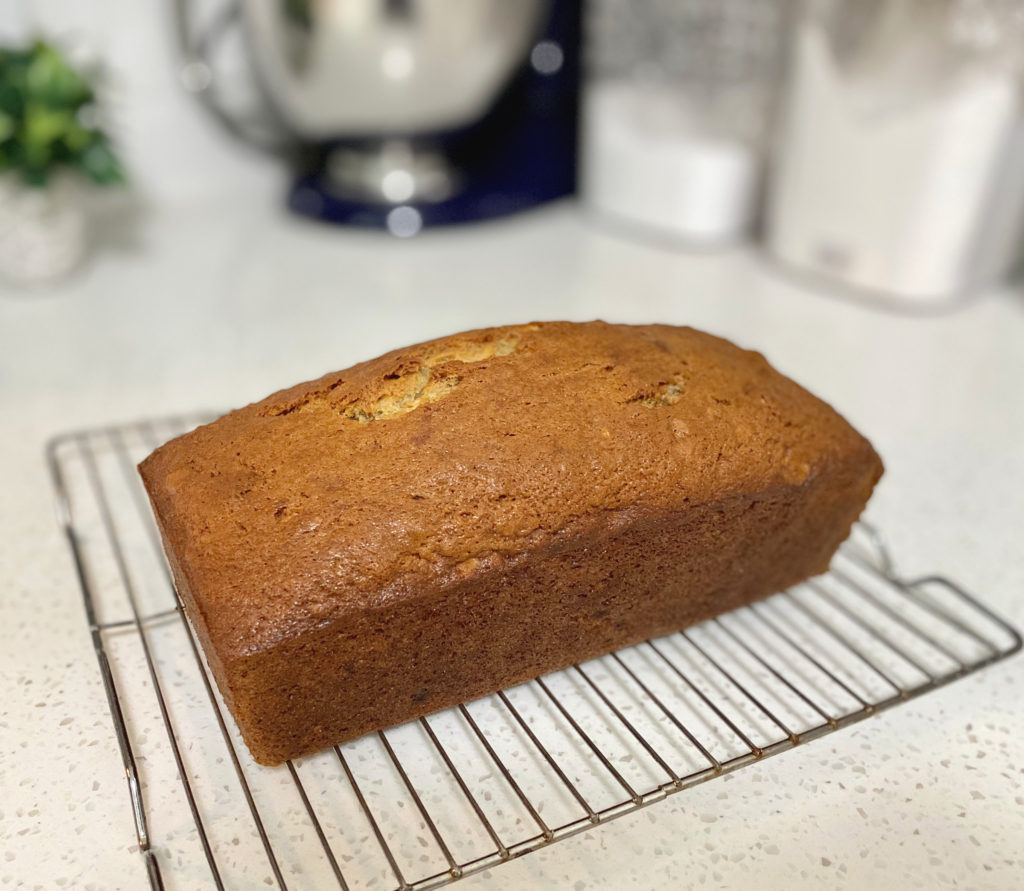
[140,322,882,764]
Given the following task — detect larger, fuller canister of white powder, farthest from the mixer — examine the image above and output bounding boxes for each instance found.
[766,0,1024,303]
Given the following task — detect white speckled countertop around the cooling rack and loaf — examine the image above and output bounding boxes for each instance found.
[0,197,1024,891]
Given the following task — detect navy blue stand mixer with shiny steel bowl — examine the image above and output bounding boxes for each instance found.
[175,0,580,236]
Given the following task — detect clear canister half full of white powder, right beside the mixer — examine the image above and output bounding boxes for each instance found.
[580,0,788,246]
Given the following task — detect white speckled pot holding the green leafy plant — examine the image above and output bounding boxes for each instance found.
[0,173,86,286]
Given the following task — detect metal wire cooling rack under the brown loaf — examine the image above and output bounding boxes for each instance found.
[48,417,1021,891]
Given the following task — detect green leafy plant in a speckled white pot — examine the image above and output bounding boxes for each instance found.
[0,41,124,284]
